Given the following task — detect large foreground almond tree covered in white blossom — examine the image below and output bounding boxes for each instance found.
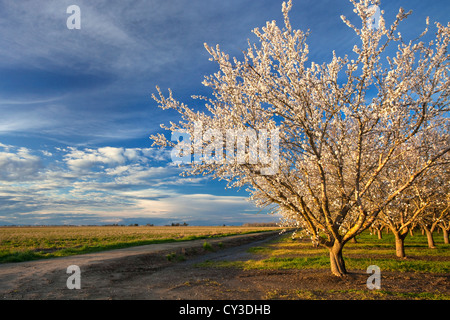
[151,0,450,276]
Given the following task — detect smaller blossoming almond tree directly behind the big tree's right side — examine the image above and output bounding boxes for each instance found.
[373,135,450,258]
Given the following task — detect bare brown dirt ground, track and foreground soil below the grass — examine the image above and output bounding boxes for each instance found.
[0,232,450,300]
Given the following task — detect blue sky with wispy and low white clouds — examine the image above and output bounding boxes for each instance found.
[0,0,450,225]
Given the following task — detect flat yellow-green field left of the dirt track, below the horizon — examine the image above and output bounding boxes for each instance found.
[0,226,277,263]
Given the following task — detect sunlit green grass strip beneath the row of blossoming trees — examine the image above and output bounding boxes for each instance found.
[202,233,450,274]
